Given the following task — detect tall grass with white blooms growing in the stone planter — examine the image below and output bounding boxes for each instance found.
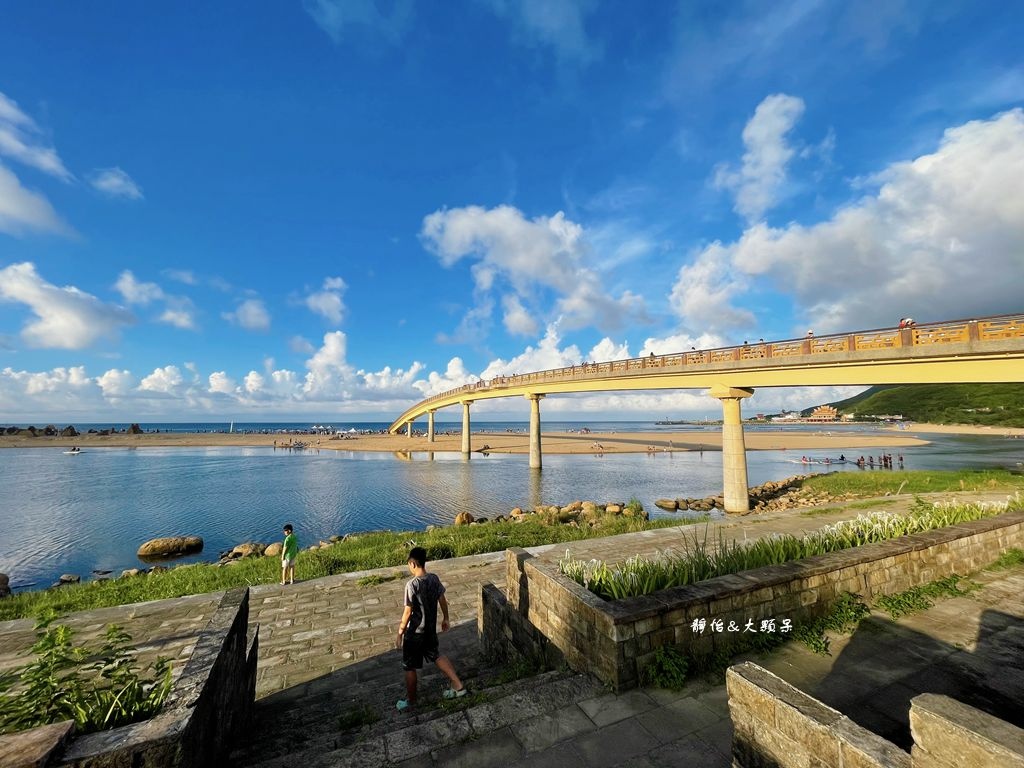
[559,495,1024,600]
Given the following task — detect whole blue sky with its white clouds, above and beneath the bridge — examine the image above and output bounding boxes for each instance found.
[0,0,1024,422]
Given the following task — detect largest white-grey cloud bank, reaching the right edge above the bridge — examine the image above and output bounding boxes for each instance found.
[688,109,1024,332]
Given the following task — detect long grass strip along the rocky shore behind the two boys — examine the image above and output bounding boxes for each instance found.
[0,515,686,621]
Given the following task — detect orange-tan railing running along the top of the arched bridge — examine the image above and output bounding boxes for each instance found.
[403,314,1024,421]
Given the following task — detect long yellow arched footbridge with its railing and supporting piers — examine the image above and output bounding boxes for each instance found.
[390,314,1024,512]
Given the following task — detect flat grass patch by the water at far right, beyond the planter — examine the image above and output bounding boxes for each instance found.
[802,469,1024,496]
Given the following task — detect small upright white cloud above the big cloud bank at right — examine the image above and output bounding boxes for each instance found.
[715,93,804,221]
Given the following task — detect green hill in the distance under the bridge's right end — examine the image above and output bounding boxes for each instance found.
[828,384,1024,427]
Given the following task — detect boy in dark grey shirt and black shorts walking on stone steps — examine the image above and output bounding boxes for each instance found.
[395,547,466,712]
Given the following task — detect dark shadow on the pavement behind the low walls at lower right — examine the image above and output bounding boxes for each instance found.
[798,598,1024,751]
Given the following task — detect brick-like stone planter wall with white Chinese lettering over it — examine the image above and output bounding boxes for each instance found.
[478,512,1024,690]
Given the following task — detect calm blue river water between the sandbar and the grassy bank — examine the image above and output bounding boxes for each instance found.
[0,423,1024,589]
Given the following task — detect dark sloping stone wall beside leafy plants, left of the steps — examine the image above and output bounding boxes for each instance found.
[51,589,259,768]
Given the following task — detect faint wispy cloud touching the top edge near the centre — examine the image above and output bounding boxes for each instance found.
[489,0,601,63]
